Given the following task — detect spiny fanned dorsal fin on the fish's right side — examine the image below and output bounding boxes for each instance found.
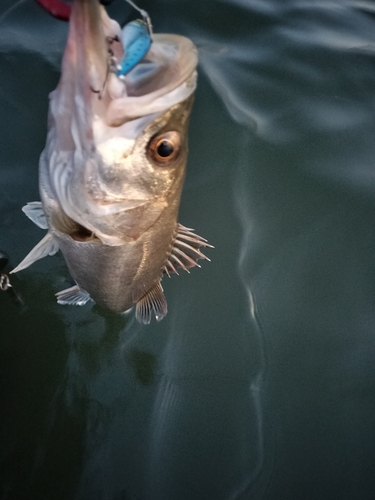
[163,224,214,276]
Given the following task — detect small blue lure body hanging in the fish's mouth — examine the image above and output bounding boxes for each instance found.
[116,19,152,78]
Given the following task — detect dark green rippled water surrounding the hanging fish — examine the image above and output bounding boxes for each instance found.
[0,0,375,500]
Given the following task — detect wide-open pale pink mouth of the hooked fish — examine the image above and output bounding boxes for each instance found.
[59,0,198,129]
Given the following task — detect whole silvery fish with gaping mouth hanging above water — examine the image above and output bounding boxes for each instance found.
[12,0,213,324]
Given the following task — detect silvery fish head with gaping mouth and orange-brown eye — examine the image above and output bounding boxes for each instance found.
[40,0,197,245]
